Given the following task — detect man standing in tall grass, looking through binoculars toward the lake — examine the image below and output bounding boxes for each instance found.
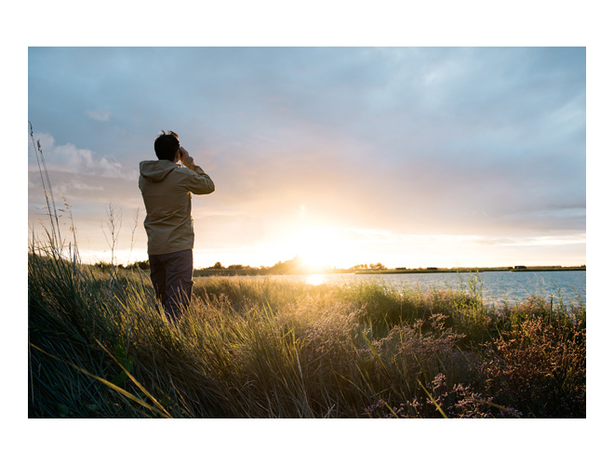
[139,131,215,322]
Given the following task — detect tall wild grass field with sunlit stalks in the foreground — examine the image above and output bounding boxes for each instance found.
[28,243,586,418]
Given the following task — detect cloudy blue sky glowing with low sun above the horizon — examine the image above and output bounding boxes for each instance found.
[28,46,586,268]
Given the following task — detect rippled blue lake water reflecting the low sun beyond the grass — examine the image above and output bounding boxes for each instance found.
[236,270,586,306]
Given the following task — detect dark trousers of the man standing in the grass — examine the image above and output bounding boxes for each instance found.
[149,249,194,322]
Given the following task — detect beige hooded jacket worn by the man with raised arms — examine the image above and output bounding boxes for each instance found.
[139,157,215,255]
